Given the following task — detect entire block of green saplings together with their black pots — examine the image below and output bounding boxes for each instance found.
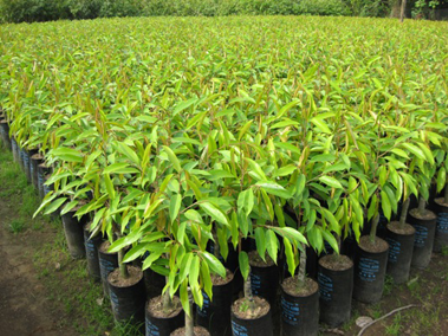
[0,18,448,336]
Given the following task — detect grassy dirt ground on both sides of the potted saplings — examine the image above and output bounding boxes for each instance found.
[0,153,448,336]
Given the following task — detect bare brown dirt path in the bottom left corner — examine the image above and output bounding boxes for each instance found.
[0,199,79,336]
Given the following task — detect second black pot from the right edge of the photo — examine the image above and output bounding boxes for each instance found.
[408,209,437,269]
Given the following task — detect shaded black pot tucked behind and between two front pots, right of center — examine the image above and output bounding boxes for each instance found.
[249,251,280,307]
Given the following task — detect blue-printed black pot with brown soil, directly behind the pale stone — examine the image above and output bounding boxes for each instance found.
[353,236,389,303]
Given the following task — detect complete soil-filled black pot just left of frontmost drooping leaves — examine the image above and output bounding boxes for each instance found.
[107,266,146,324]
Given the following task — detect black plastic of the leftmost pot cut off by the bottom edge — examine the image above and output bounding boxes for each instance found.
[145,298,185,336]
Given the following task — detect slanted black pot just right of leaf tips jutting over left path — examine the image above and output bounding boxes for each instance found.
[61,210,89,259]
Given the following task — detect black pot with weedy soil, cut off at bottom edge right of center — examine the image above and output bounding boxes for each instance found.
[231,296,274,336]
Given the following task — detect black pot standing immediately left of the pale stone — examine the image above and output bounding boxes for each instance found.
[318,255,353,327]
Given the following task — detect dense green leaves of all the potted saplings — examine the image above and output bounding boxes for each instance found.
[0,17,448,312]
